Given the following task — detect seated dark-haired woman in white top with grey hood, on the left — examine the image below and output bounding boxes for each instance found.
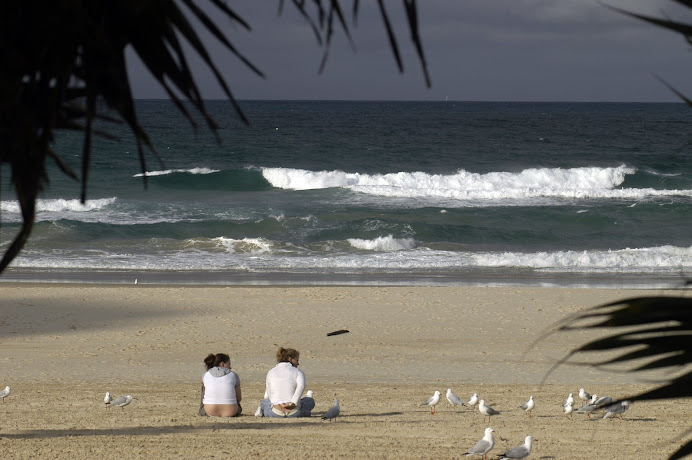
[202,353,242,417]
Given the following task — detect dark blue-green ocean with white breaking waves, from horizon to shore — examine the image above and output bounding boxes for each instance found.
[0,101,692,287]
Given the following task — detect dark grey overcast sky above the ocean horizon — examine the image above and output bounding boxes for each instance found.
[129,0,692,102]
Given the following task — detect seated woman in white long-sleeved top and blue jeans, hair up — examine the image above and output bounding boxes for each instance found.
[260,348,315,417]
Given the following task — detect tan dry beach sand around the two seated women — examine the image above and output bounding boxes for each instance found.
[0,283,692,459]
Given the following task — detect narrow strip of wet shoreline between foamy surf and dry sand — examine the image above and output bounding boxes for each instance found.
[0,268,690,289]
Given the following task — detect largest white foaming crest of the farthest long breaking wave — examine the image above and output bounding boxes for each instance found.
[262,165,692,200]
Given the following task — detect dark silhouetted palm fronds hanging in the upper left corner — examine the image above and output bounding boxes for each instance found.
[0,0,429,272]
